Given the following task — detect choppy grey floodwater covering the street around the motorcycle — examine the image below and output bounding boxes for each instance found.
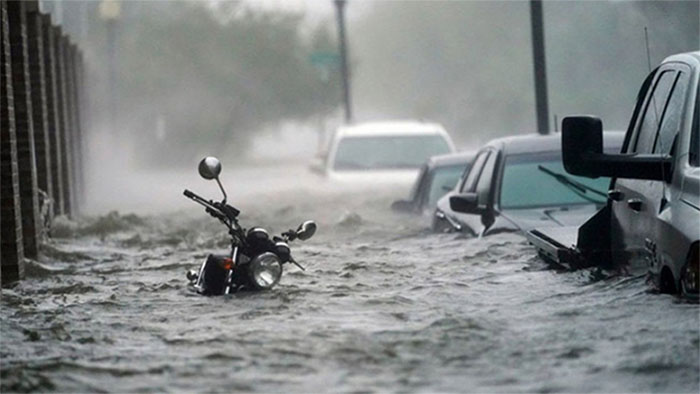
[0,165,700,393]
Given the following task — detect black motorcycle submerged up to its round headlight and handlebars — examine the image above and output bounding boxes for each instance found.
[184,157,316,295]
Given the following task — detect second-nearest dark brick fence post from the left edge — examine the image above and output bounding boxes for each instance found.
[7,1,41,258]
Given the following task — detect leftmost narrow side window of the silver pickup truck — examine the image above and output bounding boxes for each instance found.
[632,70,676,153]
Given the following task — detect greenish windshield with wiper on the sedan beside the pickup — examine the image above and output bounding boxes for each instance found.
[501,153,610,209]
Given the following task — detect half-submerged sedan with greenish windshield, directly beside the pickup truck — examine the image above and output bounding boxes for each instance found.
[432,132,623,236]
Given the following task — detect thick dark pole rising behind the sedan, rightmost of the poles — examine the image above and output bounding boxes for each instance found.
[530,0,549,134]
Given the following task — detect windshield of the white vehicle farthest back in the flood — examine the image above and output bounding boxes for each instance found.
[333,135,450,171]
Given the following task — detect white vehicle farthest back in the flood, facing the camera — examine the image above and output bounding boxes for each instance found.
[313,121,455,185]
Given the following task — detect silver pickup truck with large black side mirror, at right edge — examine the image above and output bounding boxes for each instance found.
[528,52,700,299]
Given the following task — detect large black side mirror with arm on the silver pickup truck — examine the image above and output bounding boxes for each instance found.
[561,116,672,181]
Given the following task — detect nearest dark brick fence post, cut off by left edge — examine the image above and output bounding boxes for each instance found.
[0,0,24,284]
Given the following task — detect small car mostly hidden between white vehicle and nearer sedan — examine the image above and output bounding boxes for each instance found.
[391,152,476,214]
